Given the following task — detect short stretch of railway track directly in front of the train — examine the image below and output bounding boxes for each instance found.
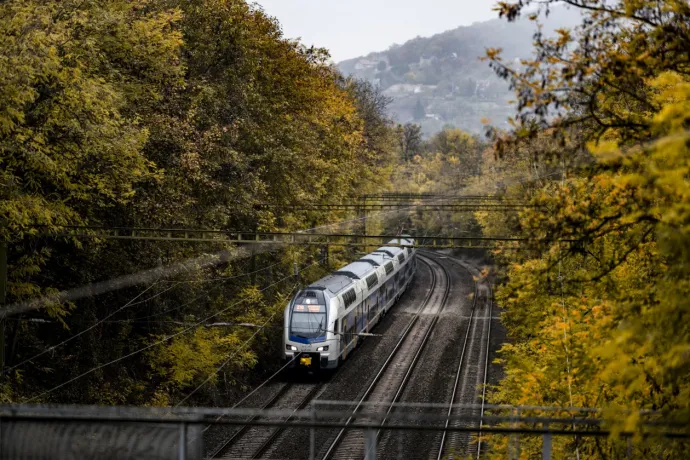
[210,383,323,460]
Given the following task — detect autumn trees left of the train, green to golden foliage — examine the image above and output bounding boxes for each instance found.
[0,0,482,406]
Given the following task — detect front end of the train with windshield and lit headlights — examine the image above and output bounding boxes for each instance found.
[283,288,338,371]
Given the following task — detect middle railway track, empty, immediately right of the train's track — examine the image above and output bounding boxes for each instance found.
[321,256,451,460]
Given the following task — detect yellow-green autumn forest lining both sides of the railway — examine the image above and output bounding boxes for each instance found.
[5,0,690,458]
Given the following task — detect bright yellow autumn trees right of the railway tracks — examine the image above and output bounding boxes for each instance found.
[472,0,690,458]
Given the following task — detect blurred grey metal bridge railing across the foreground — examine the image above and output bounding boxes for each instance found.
[0,401,690,460]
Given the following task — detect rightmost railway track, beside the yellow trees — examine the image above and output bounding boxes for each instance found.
[431,256,493,460]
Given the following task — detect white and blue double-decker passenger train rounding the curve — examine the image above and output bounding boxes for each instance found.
[283,235,417,371]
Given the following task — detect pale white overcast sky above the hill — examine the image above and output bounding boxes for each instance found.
[250,0,498,62]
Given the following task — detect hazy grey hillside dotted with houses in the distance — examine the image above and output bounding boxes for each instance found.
[338,8,579,135]
